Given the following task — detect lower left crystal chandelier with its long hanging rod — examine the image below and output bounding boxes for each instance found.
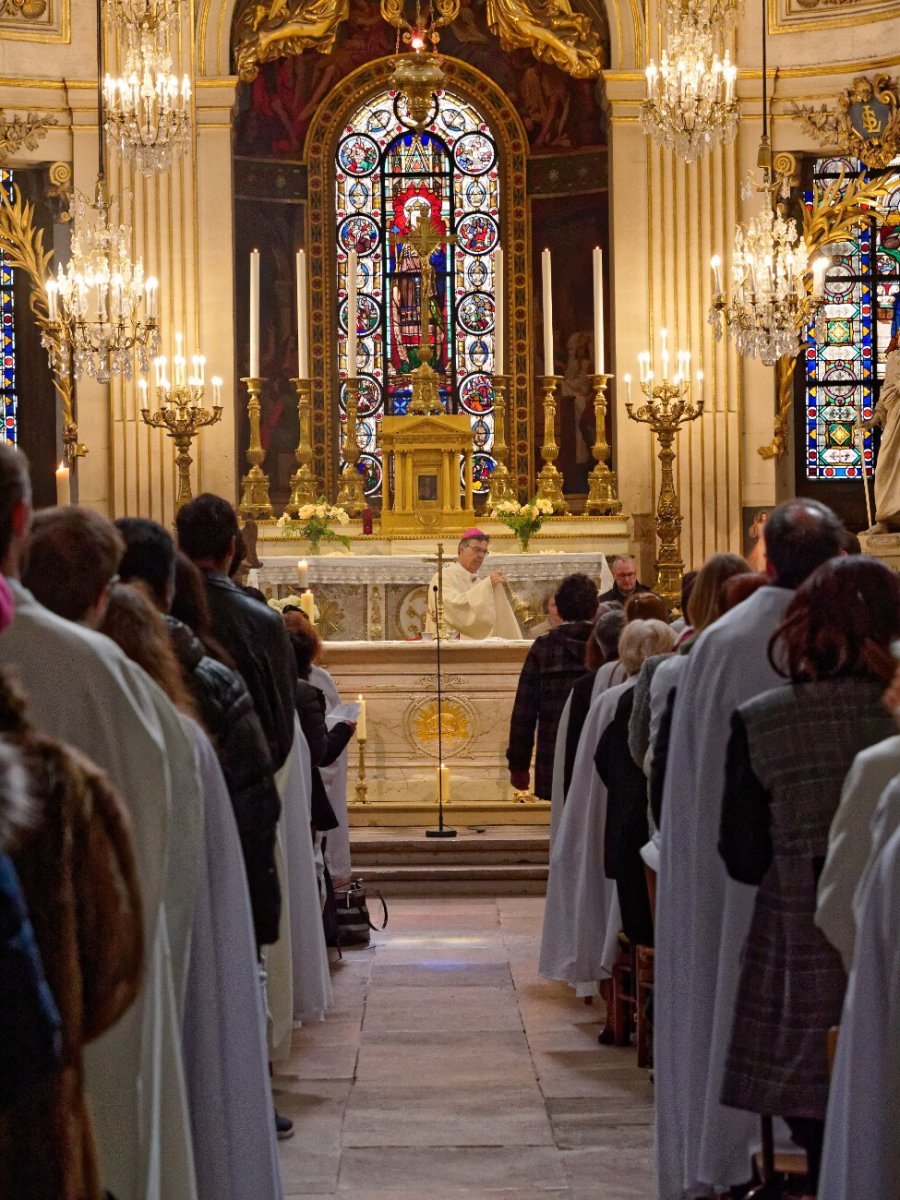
[41,4,160,383]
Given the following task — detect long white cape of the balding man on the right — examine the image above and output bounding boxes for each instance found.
[654,587,793,1200]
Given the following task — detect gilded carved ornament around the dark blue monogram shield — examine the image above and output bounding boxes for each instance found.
[791,74,900,169]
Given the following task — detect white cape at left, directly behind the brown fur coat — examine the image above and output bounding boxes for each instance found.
[0,580,202,1200]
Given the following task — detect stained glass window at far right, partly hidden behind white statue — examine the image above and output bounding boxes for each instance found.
[805,158,900,481]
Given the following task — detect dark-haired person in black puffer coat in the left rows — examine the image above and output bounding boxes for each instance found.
[116,517,281,946]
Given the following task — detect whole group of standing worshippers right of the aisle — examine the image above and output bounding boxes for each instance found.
[525,499,900,1200]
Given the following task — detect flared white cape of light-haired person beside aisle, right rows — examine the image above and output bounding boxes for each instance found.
[538,676,637,992]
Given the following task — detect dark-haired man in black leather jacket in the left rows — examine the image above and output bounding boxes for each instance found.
[175,492,296,770]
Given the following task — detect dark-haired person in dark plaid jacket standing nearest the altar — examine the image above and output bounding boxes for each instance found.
[506,575,598,800]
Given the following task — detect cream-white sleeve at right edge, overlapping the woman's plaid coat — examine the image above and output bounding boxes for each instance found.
[816,734,900,971]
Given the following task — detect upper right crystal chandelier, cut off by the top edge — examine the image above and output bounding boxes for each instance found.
[641,0,740,162]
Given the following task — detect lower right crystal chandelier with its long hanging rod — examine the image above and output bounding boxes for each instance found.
[709,0,828,367]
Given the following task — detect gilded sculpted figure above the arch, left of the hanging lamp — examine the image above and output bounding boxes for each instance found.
[234,0,350,83]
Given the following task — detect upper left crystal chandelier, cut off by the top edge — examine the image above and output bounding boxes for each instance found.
[103,0,191,175]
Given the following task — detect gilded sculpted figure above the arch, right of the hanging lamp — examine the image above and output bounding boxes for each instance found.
[487,0,605,79]
